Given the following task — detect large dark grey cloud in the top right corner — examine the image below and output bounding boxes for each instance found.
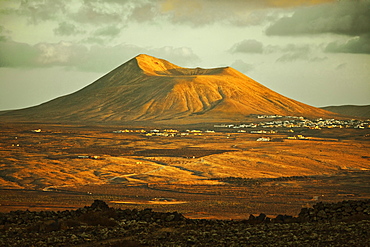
[266,0,370,36]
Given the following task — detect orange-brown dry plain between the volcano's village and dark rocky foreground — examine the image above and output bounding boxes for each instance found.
[0,123,370,219]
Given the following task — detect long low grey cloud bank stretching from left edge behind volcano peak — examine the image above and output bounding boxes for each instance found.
[0,37,199,72]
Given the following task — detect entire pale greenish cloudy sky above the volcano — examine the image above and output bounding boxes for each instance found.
[0,0,370,110]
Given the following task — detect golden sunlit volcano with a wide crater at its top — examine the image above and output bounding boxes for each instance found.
[4,55,334,123]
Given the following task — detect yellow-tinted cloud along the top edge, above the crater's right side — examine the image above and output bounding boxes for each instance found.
[158,0,335,26]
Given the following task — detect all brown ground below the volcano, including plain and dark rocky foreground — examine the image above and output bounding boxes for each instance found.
[0,123,370,247]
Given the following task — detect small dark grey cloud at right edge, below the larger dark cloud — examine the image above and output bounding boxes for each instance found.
[325,35,370,54]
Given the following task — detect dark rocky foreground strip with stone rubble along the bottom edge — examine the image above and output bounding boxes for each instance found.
[0,200,370,246]
